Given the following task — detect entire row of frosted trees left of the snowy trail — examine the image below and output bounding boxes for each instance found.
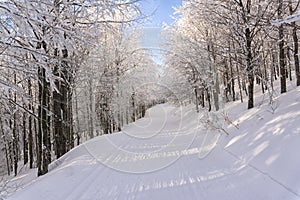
[0,0,156,175]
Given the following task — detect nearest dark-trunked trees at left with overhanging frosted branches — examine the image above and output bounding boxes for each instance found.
[0,0,143,175]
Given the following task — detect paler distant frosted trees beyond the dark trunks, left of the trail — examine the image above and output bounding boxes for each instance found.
[75,24,157,138]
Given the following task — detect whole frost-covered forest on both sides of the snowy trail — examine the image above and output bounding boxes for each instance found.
[0,0,300,181]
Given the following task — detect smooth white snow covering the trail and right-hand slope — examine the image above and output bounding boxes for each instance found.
[3,87,300,200]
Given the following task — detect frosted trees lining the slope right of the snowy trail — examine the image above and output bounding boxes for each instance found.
[166,0,300,111]
